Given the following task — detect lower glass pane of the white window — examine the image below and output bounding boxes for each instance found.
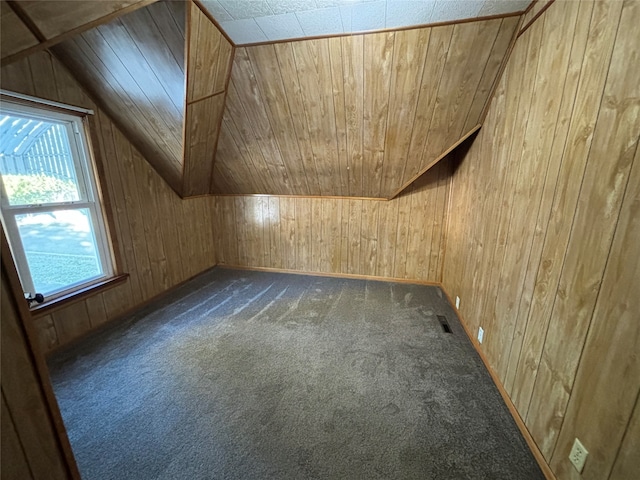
[16,208,103,296]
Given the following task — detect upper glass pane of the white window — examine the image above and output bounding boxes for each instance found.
[0,114,80,205]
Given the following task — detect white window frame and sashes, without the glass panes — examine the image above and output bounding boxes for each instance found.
[0,90,115,302]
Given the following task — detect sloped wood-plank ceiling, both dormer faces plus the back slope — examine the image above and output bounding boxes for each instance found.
[3,0,519,198]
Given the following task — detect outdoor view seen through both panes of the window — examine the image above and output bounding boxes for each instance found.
[0,111,103,296]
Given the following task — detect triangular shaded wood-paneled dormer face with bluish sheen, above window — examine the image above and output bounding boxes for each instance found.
[52,1,189,192]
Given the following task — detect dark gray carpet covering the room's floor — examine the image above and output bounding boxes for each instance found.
[49,268,544,480]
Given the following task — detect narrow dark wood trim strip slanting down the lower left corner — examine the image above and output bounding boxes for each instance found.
[0,226,81,480]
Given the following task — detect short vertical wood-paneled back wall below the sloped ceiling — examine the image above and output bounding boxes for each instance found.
[214,161,450,282]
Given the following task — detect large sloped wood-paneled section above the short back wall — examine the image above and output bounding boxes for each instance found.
[214,17,518,198]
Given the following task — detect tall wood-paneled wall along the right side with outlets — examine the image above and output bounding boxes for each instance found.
[443,1,640,480]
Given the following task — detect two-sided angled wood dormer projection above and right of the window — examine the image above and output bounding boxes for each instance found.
[52,1,232,197]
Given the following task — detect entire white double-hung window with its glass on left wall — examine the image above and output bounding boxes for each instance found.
[0,92,113,300]
